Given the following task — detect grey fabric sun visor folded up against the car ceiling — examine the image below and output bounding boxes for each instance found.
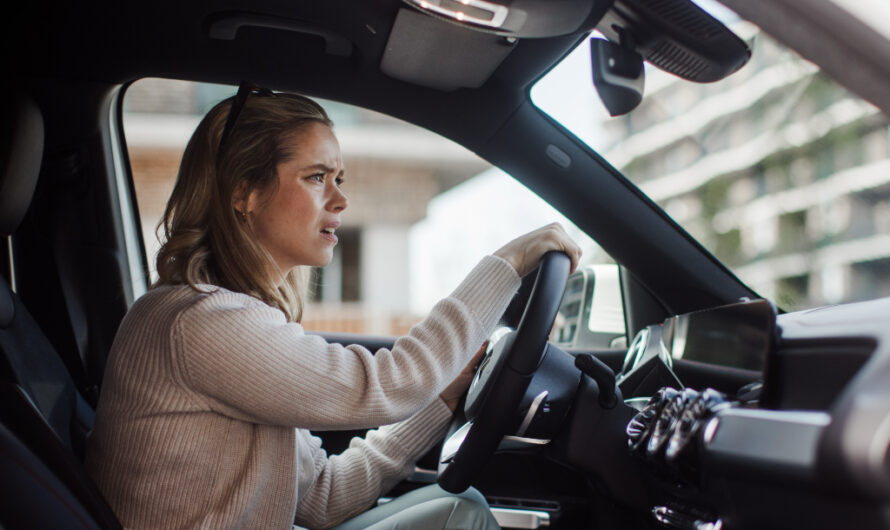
[380,8,516,91]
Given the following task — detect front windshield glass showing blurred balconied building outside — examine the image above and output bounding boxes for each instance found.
[532,6,890,310]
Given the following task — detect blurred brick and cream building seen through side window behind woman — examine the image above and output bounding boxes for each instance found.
[124,79,489,335]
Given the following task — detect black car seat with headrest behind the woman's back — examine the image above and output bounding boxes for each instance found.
[0,90,121,530]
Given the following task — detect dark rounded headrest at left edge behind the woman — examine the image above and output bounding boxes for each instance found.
[0,89,43,236]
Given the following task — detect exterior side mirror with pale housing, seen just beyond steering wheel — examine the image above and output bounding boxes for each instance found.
[551,265,627,349]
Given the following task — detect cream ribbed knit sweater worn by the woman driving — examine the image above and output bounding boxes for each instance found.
[87,256,519,529]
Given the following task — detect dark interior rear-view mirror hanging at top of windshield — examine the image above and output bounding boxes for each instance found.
[590,38,646,116]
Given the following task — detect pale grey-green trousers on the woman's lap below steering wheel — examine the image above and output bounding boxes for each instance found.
[332,485,500,530]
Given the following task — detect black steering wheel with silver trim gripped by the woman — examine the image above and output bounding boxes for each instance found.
[437,252,571,493]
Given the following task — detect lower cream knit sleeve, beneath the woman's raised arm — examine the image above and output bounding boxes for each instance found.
[295,399,451,528]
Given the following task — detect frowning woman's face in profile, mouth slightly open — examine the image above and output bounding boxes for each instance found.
[241,123,349,276]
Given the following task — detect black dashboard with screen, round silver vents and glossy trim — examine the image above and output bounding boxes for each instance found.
[617,299,890,530]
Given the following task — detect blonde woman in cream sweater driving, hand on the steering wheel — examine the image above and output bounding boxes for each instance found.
[87,84,580,529]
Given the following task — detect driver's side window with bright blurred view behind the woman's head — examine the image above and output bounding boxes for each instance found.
[124,79,609,335]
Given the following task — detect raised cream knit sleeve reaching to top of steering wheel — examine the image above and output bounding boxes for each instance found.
[172,256,519,430]
